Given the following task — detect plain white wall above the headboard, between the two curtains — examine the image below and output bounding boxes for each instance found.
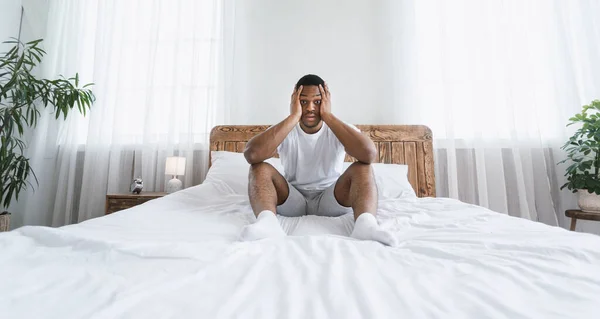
[226,0,396,124]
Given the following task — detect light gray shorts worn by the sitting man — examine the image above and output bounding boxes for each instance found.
[277,182,352,217]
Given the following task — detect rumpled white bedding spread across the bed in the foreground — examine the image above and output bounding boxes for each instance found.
[0,184,600,319]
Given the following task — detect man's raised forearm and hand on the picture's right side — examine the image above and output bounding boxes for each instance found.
[319,84,377,164]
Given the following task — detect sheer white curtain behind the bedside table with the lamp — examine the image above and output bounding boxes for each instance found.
[14,0,226,230]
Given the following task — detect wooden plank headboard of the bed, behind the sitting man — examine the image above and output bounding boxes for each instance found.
[210,125,435,197]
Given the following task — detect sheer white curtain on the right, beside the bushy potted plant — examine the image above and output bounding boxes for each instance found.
[389,0,600,230]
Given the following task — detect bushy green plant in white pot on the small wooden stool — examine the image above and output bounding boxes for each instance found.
[560,100,600,212]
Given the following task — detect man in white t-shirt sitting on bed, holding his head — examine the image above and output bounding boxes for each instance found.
[241,74,394,245]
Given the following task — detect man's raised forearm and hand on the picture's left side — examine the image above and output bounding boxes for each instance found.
[244,86,302,164]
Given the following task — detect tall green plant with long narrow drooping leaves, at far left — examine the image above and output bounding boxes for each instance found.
[0,39,95,208]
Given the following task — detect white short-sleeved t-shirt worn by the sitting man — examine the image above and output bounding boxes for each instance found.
[277,122,360,191]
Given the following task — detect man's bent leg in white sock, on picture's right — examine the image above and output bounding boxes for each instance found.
[334,162,396,246]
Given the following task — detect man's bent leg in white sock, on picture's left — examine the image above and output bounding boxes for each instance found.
[240,162,289,241]
